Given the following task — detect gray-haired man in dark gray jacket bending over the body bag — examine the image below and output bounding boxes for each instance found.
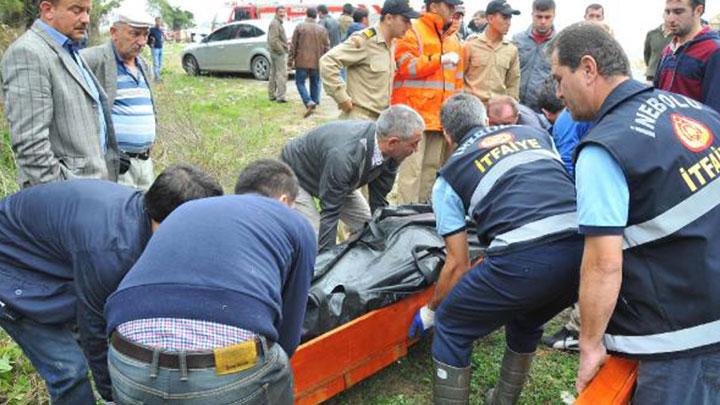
[281,104,425,250]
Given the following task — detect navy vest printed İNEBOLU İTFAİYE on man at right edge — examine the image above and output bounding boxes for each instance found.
[577,80,720,359]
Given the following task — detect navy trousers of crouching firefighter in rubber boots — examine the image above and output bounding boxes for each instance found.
[432,235,583,367]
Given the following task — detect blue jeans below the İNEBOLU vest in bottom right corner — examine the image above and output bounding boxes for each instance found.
[633,352,720,405]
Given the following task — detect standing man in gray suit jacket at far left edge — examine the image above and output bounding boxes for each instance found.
[0,0,126,187]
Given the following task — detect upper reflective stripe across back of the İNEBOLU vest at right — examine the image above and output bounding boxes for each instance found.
[623,177,720,249]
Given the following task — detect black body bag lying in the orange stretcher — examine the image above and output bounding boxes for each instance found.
[303,205,482,340]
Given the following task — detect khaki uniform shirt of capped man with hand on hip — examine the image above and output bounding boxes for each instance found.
[320,25,395,115]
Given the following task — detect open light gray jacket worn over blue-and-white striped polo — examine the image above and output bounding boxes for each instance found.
[80,41,157,110]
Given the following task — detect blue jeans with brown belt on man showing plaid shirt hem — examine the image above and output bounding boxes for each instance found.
[108,338,293,405]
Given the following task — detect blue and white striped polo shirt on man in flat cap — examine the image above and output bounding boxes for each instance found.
[112,58,155,153]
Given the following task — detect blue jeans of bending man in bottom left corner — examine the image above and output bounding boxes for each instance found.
[0,316,95,405]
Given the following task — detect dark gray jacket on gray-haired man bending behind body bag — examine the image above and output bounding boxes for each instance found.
[281,121,398,250]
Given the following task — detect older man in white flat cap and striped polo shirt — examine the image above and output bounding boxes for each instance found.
[80,14,157,190]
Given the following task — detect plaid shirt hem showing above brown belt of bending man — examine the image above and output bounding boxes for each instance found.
[117,318,255,351]
